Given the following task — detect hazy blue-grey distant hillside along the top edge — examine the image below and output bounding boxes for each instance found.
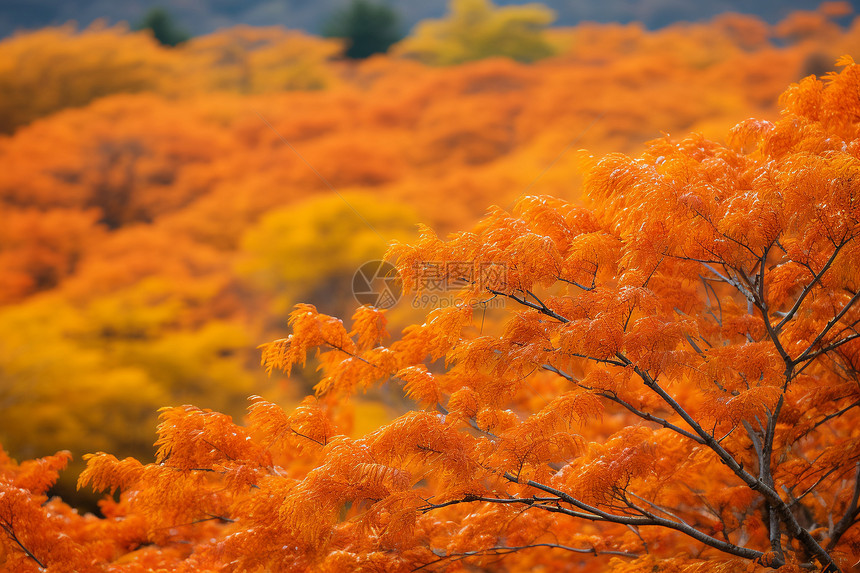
[0,0,860,36]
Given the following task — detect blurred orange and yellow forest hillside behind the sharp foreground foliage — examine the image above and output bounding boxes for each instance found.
[0,0,860,510]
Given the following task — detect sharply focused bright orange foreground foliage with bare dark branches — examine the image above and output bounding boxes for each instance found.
[0,40,860,573]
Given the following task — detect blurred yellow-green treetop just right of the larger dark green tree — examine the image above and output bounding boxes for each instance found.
[397,0,555,65]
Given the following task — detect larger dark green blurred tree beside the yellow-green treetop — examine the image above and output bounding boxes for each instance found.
[323,0,403,59]
